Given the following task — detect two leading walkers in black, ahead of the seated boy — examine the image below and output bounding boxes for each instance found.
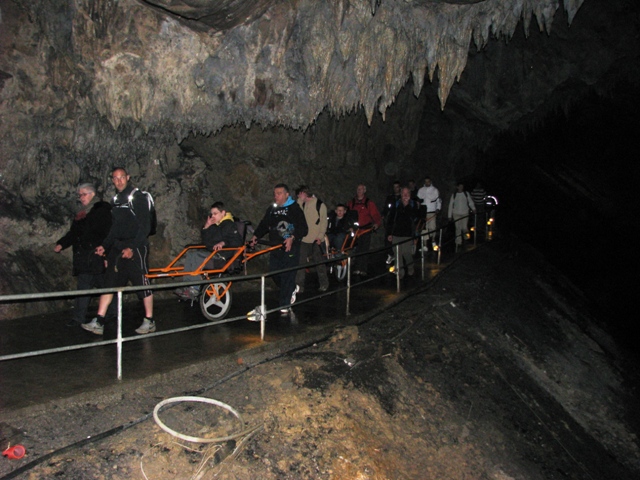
[54,167,156,335]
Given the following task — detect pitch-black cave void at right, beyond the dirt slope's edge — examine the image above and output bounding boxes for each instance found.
[480,84,640,346]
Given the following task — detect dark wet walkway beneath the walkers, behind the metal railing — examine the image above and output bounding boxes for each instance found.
[0,249,450,409]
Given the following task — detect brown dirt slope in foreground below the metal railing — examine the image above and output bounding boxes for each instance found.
[0,241,640,480]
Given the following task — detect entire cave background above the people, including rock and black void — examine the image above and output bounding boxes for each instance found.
[0,0,640,344]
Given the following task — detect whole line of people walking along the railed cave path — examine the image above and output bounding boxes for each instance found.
[54,171,486,335]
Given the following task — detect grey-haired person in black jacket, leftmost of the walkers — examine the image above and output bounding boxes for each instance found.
[53,183,111,327]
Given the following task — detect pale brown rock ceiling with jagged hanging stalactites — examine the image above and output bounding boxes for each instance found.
[0,0,582,139]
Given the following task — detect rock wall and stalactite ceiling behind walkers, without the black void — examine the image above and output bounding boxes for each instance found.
[0,0,637,315]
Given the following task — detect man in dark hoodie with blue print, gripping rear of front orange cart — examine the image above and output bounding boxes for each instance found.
[251,183,308,316]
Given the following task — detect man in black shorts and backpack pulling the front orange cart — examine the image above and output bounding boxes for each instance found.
[82,167,156,335]
